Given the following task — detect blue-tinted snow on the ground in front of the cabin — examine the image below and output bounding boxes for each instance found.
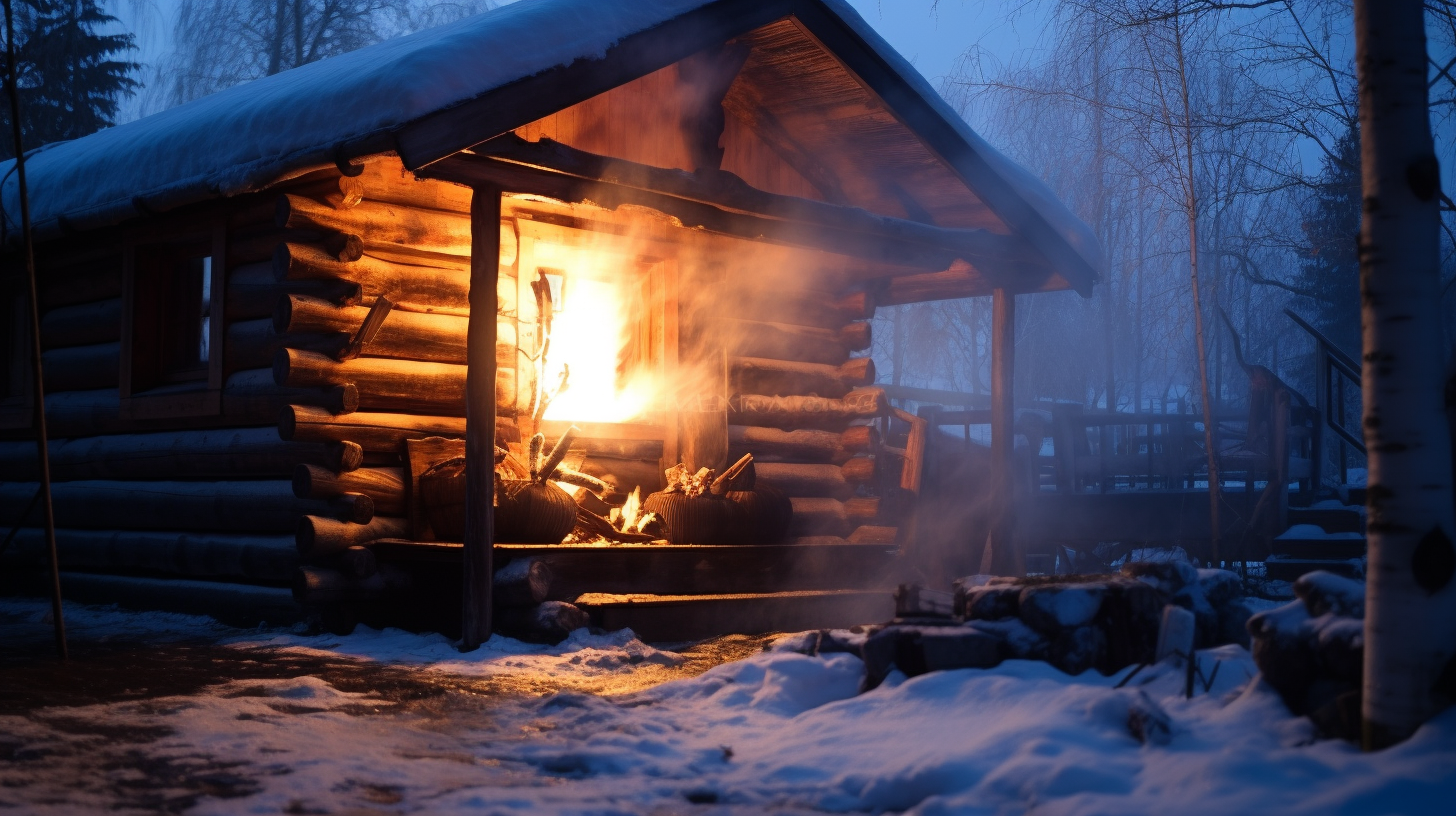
[0,591,1456,816]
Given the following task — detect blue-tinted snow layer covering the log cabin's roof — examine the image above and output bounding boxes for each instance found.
[0,0,1101,289]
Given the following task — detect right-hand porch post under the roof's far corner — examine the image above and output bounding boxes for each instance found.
[981,289,1026,576]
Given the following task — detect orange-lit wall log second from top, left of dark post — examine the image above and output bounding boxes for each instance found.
[274,194,470,256]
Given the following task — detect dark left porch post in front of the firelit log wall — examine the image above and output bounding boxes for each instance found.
[460,187,501,651]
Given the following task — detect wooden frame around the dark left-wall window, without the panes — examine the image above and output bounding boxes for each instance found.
[116,219,227,420]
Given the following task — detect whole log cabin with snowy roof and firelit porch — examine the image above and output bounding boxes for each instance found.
[0,0,1101,646]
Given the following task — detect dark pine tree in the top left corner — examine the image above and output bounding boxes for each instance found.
[0,0,137,159]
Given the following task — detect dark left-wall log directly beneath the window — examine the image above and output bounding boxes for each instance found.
[0,428,345,481]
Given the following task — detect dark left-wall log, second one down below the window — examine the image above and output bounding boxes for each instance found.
[0,479,329,533]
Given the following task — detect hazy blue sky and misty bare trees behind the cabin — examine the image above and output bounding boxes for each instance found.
[93,0,1456,434]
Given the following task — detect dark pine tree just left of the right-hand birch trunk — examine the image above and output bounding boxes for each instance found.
[1297,122,1360,357]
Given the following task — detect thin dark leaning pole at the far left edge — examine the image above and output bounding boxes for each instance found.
[4,0,67,660]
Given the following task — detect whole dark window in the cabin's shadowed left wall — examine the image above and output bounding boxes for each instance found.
[121,231,221,418]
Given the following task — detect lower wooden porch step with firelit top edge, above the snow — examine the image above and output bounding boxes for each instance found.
[575,590,894,643]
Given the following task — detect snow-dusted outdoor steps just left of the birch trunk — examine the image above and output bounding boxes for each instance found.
[1264,501,1366,581]
